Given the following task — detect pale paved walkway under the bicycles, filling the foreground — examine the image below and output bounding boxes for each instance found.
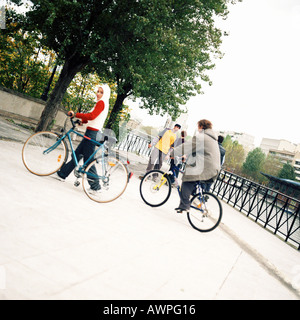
[0,119,300,300]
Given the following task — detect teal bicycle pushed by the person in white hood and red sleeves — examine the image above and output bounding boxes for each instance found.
[22,118,131,203]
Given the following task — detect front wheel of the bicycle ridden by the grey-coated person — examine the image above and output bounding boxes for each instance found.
[140,170,172,207]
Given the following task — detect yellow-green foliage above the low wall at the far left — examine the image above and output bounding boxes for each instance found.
[0,12,55,98]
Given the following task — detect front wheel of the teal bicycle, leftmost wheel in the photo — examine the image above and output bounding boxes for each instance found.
[22,131,67,176]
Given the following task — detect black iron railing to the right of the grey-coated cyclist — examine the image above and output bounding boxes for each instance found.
[212,170,300,250]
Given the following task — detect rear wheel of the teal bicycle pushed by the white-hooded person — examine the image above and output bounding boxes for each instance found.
[82,156,128,203]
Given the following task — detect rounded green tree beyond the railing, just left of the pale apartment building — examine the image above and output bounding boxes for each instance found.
[243,148,266,180]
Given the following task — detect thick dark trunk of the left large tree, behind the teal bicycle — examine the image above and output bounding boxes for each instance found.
[35,55,89,132]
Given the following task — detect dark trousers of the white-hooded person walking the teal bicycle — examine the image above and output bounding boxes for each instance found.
[57,130,101,190]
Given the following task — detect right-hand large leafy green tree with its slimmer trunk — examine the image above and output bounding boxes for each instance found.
[94,0,234,127]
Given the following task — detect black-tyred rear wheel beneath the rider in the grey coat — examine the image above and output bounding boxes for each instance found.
[187,192,223,232]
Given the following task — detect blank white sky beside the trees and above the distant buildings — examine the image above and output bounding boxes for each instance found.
[132,0,300,145]
